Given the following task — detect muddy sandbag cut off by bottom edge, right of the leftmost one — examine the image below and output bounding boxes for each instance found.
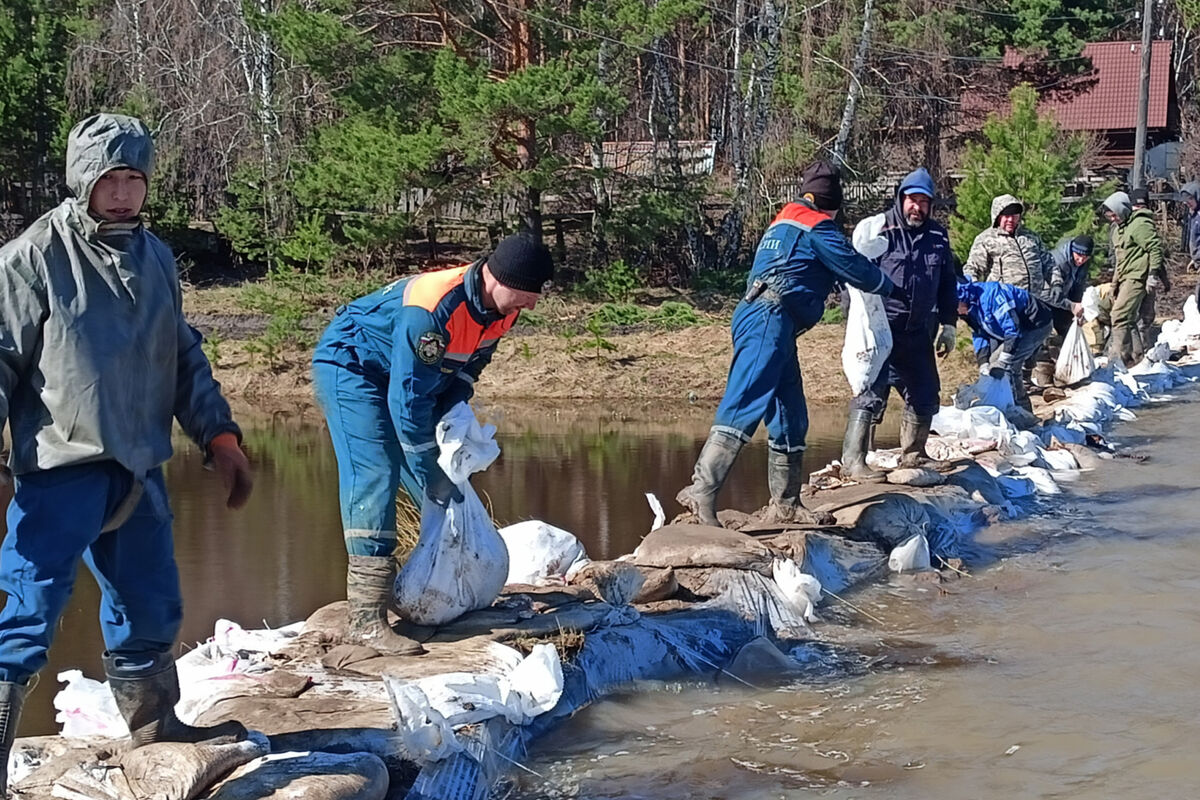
[206,752,389,800]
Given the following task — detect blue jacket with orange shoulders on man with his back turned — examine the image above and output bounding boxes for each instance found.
[746,200,892,333]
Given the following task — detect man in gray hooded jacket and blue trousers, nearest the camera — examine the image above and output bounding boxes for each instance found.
[0,114,251,794]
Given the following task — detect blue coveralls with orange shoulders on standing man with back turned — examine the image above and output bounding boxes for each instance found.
[713,201,892,452]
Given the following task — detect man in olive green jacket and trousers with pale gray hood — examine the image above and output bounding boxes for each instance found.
[1103,192,1163,367]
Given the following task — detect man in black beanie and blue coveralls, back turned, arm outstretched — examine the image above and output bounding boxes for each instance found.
[676,162,895,525]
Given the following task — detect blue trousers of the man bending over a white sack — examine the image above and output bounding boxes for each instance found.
[312,337,425,555]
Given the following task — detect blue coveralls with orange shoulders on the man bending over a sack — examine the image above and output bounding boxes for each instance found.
[312,263,517,557]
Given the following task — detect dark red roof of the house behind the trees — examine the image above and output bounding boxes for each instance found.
[1036,40,1171,131]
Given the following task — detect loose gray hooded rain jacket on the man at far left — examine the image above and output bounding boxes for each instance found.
[0,114,240,479]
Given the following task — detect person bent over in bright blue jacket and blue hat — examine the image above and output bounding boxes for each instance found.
[958,281,1051,411]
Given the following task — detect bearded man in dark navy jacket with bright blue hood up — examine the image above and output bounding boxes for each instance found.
[841,167,958,481]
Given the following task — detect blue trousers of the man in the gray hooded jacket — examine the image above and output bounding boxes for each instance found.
[0,462,184,685]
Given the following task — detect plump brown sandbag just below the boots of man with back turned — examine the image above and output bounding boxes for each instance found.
[635,525,775,577]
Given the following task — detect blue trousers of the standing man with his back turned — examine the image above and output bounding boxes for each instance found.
[713,297,809,452]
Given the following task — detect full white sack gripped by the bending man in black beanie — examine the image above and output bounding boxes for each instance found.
[392,403,509,625]
